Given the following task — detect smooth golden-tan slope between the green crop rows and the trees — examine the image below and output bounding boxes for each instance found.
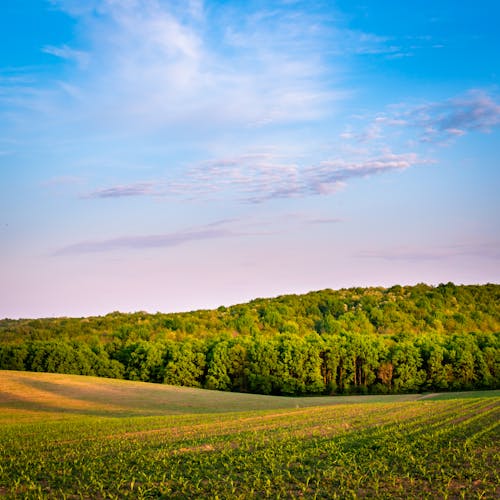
[0,370,476,422]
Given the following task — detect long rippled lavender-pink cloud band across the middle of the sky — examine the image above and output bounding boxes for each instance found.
[81,151,430,203]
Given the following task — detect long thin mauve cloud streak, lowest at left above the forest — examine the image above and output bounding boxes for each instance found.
[53,221,241,256]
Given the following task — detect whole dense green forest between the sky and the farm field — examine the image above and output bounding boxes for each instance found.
[0,283,500,395]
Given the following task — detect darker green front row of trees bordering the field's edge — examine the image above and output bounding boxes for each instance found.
[0,333,500,395]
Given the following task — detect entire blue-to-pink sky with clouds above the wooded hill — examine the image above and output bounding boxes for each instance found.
[0,0,500,318]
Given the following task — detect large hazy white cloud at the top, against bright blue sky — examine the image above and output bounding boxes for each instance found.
[37,0,338,134]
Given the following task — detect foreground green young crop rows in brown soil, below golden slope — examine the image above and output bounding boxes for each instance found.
[0,398,500,499]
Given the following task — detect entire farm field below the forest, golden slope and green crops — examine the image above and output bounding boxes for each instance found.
[0,371,500,499]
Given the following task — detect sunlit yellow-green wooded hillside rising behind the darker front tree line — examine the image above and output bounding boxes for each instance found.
[0,283,500,343]
